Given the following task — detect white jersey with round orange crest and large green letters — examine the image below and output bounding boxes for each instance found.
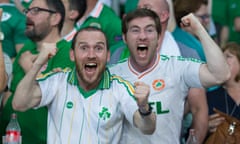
[110,55,202,144]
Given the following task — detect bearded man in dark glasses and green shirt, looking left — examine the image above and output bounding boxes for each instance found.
[0,0,74,144]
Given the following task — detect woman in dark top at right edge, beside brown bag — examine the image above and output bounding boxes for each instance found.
[207,42,240,141]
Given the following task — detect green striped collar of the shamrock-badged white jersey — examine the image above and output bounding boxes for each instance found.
[68,67,111,98]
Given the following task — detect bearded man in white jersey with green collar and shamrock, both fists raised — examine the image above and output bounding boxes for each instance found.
[13,27,156,144]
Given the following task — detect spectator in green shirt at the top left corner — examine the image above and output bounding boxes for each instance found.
[0,0,28,60]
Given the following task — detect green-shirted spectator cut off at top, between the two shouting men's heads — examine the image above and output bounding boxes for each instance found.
[77,0,123,56]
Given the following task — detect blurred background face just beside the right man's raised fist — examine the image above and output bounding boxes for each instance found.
[194,4,210,30]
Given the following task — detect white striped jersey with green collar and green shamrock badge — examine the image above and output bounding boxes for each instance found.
[35,69,138,144]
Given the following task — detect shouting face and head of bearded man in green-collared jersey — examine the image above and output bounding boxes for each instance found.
[71,31,110,90]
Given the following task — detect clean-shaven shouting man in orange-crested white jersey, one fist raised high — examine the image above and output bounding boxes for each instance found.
[110,8,230,144]
